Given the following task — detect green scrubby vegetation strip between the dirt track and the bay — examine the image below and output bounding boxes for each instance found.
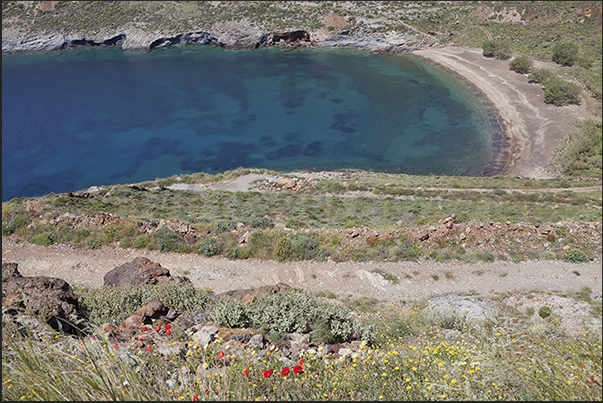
[2,165,601,262]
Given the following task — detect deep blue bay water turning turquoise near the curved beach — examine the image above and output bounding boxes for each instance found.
[2,45,501,201]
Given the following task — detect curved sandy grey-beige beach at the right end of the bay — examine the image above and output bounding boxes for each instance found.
[412,47,600,179]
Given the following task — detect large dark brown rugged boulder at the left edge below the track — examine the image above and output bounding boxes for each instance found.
[2,274,78,333]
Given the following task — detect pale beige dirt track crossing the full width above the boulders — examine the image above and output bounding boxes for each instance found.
[2,238,601,302]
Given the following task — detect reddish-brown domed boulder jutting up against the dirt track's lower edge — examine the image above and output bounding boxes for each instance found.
[103,256,190,287]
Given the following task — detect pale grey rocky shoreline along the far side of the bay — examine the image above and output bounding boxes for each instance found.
[2,23,436,54]
